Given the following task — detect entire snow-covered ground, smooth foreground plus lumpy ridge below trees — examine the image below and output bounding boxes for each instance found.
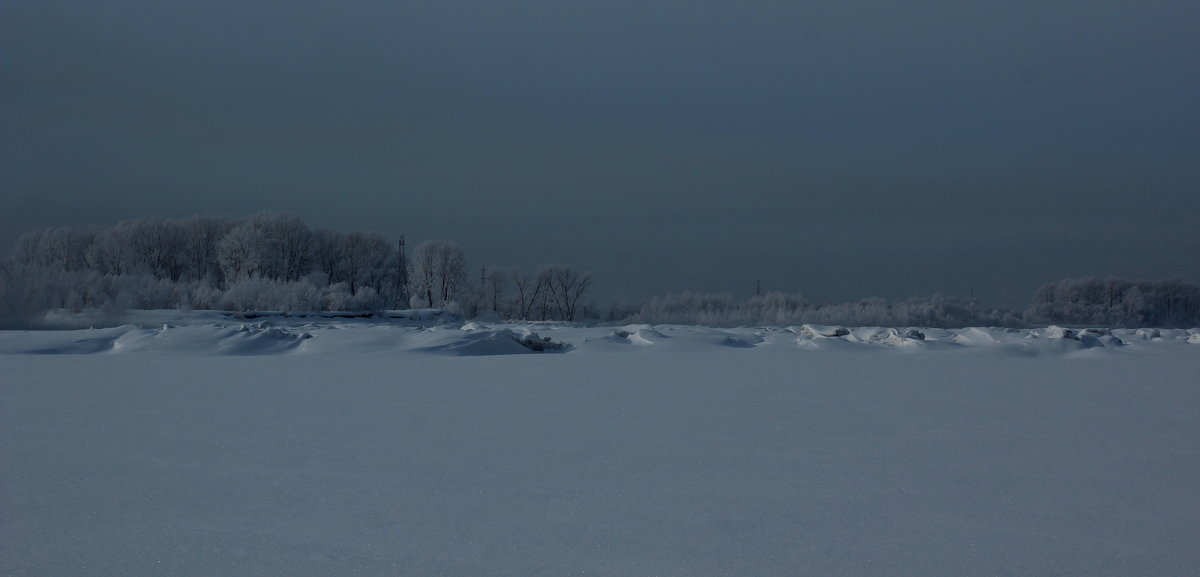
[0,312,1200,576]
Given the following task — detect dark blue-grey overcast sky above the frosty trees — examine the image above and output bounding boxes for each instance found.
[0,0,1200,306]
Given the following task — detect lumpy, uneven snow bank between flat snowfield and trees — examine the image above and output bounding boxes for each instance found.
[0,311,1180,356]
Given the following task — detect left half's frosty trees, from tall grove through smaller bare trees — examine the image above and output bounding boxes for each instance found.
[0,214,592,320]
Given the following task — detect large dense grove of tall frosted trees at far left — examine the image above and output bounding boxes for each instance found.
[0,214,415,318]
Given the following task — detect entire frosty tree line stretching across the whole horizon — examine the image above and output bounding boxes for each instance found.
[0,214,1200,327]
